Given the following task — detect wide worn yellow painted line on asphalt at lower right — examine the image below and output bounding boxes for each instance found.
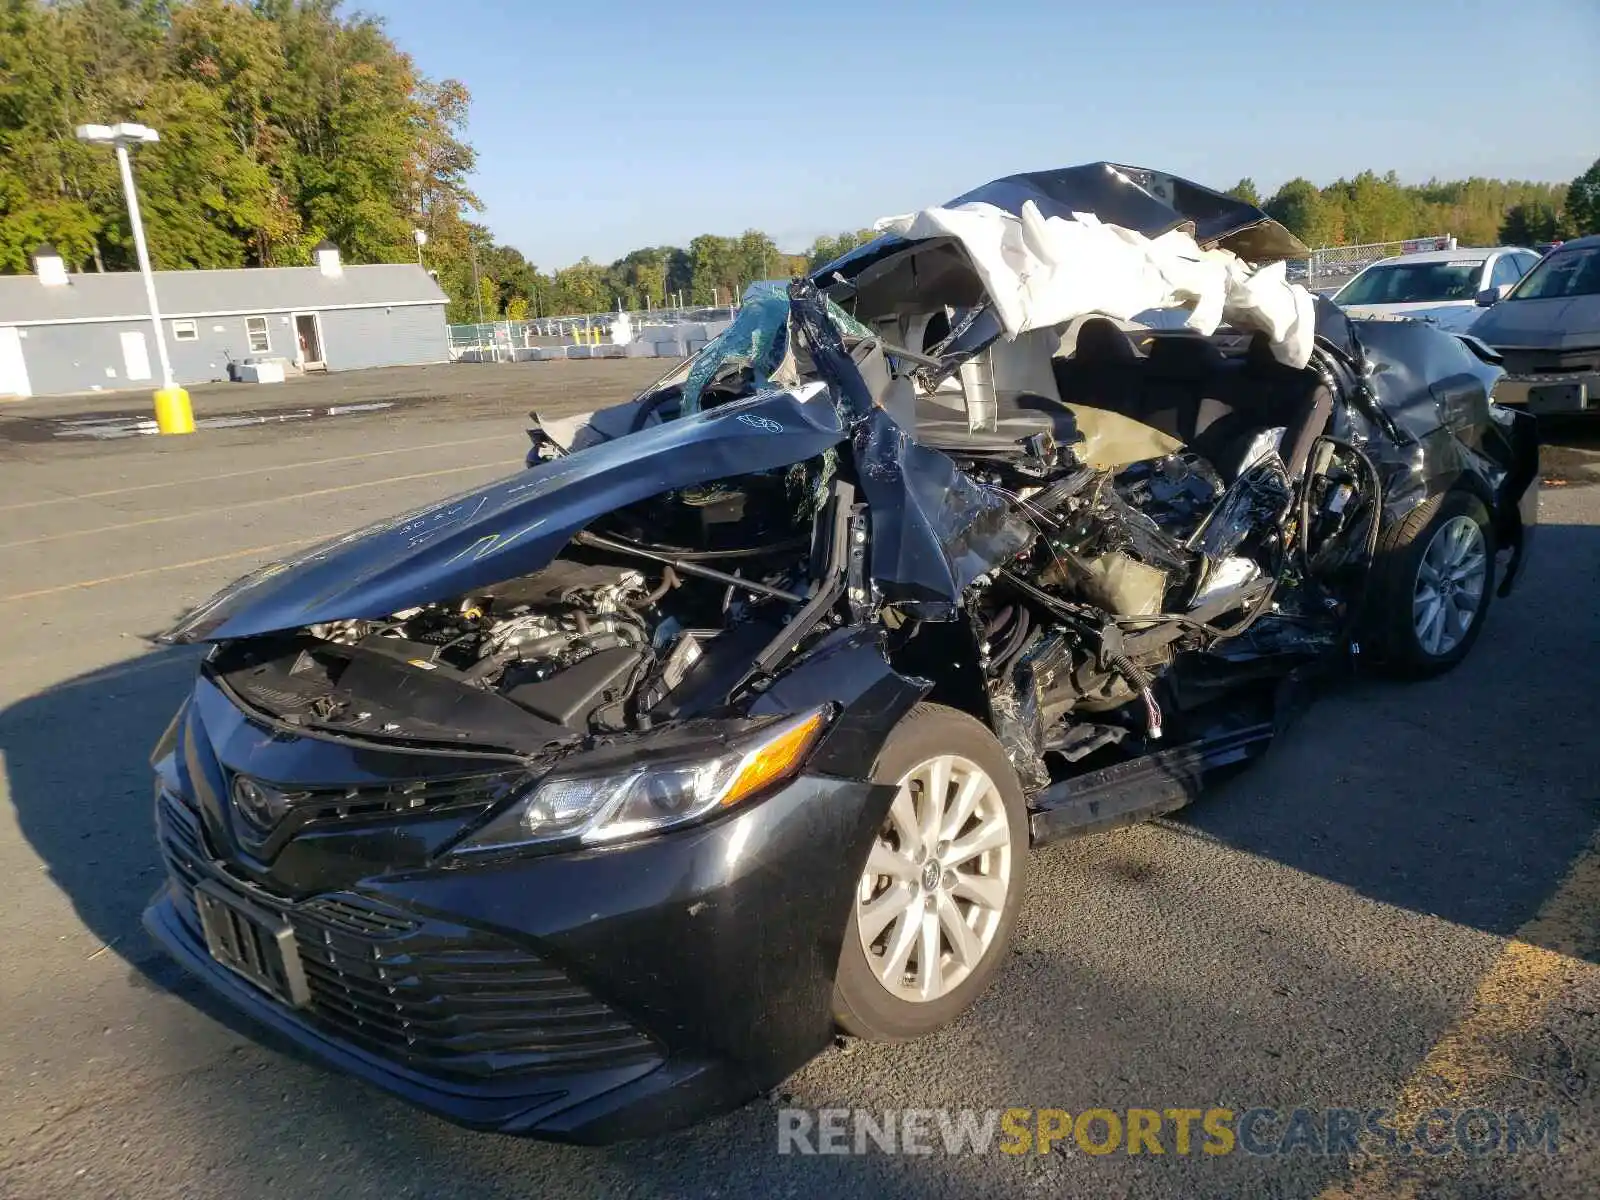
[1318,835,1600,1200]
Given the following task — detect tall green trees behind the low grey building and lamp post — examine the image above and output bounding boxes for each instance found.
[0,0,477,276]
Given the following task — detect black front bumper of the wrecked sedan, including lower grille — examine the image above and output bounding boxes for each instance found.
[144,739,891,1142]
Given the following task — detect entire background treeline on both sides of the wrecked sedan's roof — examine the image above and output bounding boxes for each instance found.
[0,0,1600,322]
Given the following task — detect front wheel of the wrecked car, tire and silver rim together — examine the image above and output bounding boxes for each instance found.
[834,704,1027,1042]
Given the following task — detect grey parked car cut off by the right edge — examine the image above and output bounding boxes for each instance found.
[1470,235,1600,413]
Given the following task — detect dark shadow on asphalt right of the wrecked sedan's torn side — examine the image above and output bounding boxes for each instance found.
[1173,525,1600,953]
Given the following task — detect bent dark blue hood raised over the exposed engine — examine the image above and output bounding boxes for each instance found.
[162,384,845,643]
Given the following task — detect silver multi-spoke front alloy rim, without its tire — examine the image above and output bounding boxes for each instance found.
[856,754,1011,1003]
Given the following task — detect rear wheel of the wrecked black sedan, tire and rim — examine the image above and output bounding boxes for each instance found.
[1374,491,1494,678]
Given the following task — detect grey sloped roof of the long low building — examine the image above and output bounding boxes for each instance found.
[0,262,446,325]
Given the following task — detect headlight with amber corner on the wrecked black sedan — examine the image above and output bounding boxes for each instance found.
[451,709,827,854]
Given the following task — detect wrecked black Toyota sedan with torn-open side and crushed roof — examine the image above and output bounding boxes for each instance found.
[146,163,1538,1142]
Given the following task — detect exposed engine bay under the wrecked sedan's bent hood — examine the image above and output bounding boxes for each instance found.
[213,464,821,750]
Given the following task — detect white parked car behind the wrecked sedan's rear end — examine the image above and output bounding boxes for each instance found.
[1333,246,1539,331]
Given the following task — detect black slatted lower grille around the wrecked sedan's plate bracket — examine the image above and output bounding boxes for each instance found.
[157,792,661,1078]
